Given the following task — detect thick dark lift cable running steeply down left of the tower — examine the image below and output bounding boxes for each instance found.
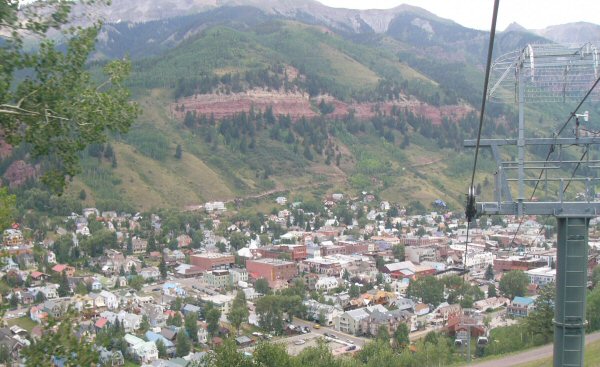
[463,0,500,276]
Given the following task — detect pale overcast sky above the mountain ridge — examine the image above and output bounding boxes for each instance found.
[318,0,600,31]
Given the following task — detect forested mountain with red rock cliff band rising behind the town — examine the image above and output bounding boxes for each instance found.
[0,0,596,210]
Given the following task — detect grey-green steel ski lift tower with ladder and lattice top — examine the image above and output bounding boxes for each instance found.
[465,43,600,367]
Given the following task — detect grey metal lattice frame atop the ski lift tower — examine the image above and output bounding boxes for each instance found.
[487,43,600,103]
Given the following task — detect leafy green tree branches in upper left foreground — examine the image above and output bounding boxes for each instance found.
[0,0,138,192]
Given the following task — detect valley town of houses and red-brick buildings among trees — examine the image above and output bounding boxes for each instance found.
[0,192,600,366]
